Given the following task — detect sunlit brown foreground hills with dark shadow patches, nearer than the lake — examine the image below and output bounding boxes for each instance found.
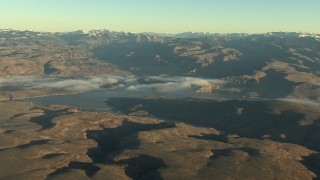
[0,102,320,179]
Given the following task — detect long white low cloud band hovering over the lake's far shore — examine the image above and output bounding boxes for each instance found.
[0,75,225,93]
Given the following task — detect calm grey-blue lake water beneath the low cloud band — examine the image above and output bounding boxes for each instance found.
[26,87,213,112]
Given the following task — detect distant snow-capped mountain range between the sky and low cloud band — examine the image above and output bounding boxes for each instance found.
[0,29,320,101]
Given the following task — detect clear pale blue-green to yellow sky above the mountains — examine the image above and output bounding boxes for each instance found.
[0,0,320,33]
